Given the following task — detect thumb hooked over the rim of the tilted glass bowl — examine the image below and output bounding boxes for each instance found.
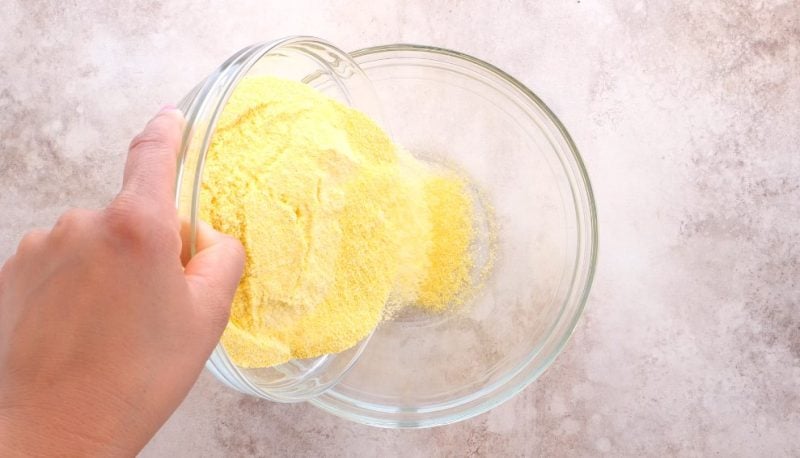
[184,221,245,330]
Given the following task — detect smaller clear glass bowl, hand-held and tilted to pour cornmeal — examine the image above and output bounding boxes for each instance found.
[175,37,388,402]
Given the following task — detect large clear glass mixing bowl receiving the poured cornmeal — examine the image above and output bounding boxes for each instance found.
[310,45,597,428]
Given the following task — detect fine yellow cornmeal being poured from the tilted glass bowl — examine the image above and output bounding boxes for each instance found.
[200,77,472,367]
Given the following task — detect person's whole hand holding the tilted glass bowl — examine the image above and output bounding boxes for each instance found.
[0,108,244,456]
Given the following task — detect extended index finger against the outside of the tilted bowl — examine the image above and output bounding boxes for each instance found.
[118,107,184,208]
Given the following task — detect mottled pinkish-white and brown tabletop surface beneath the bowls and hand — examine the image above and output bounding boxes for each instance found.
[0,0,800,456]
